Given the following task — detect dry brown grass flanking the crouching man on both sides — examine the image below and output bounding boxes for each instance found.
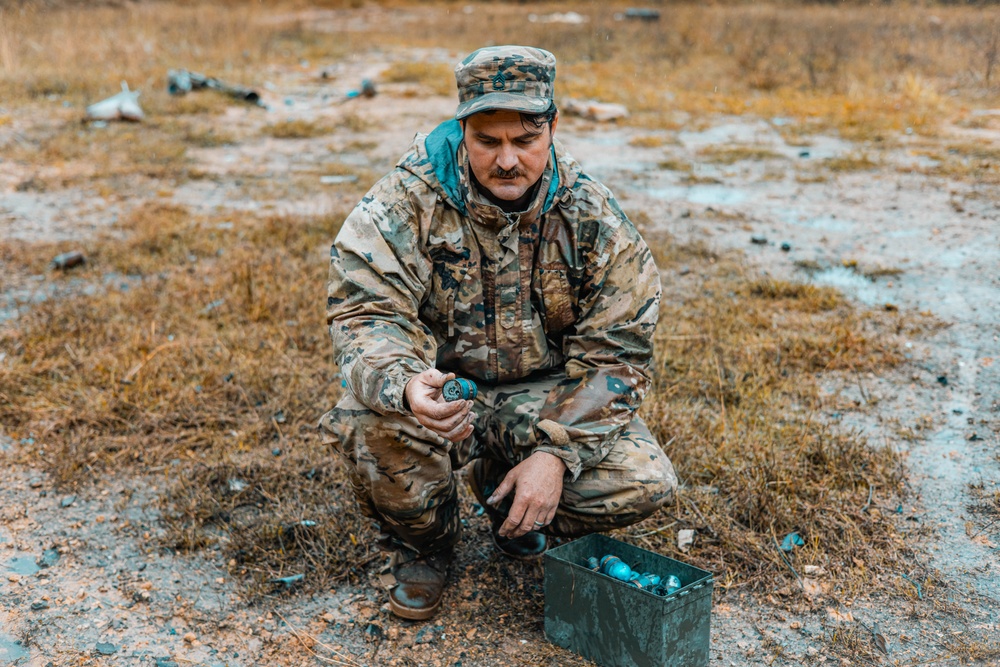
[0,205,920,594]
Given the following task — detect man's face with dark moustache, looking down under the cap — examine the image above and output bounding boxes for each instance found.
[465,110,558,201]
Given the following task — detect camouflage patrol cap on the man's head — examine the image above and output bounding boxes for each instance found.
[455,46,556,120]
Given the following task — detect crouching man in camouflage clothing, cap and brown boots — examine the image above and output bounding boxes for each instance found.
[321,46,677,619]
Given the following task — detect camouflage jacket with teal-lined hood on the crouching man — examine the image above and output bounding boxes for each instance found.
[327,121,660,479]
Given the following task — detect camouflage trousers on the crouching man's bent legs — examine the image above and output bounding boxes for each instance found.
[320,373,677,554]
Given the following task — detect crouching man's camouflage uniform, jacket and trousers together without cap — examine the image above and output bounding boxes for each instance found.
[321,62,677,553]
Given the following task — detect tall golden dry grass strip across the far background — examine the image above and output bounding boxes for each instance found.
[0,1,1000,140]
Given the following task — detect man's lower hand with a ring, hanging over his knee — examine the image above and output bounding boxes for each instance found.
[486,452,566,538]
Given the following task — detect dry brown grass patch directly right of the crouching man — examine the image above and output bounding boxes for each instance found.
[628,238,912,591]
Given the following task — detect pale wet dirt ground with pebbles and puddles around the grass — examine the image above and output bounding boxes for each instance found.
[0,23,1000,667]
